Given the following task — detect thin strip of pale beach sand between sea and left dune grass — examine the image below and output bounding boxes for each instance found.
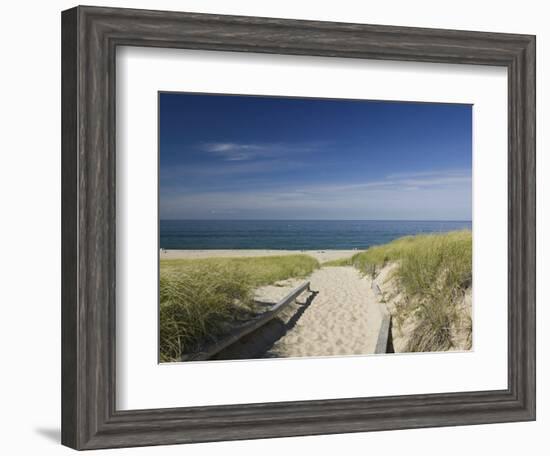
[160,249,358,263]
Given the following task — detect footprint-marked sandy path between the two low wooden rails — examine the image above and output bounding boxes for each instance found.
[265,266,382,357]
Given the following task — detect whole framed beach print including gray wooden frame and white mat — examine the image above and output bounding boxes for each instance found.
[62,7,535,449]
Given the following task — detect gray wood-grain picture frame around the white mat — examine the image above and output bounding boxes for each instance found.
[62,7,535,449]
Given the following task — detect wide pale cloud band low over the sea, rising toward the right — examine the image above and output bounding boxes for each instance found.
[161,170,471,219]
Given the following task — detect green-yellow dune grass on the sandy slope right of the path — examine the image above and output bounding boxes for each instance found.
[332,230,472,351]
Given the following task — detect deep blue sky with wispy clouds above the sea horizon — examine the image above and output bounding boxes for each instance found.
[159,93,472,220]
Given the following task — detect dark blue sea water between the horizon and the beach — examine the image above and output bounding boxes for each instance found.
[160,220,472,250]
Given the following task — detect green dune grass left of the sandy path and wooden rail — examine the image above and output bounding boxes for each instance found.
[159,255,319,362]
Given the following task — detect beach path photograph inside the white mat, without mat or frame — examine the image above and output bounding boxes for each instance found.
[158,92,473,363]
